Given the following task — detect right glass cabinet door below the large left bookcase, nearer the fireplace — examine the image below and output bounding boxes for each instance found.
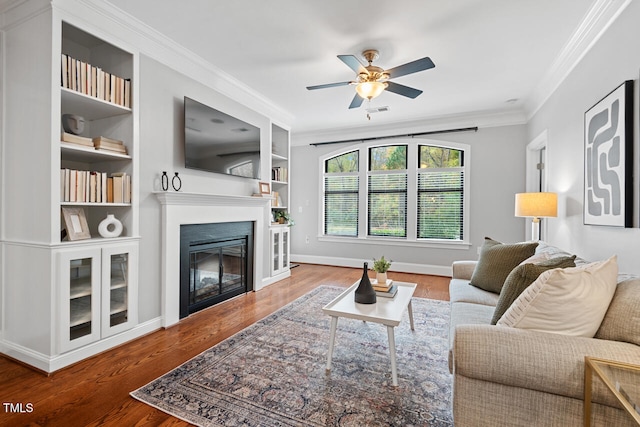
[102,245,137,338]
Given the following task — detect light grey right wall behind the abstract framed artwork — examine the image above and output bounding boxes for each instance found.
[528,2,640,274]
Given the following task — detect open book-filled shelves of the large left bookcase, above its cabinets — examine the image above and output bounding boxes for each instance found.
[59,22,137,243]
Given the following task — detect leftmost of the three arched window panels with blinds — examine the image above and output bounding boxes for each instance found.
[324,151,360,236]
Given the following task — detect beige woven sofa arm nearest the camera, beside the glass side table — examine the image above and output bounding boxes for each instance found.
[453,325,640,407]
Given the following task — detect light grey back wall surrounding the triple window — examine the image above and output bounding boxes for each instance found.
[291,125,528,274]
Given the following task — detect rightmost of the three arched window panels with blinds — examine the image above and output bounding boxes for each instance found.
[417,145,464,240]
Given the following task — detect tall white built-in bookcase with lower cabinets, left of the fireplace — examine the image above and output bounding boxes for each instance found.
[0,6,139,372]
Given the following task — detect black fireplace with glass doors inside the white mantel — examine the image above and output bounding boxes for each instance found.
[180,221,254,318]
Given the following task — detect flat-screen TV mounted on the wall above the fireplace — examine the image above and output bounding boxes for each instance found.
[184,96,260,179]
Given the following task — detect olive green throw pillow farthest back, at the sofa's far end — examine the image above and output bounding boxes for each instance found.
[470,237,538,294]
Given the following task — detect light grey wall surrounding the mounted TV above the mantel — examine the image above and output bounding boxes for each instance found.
[139,55,270,322]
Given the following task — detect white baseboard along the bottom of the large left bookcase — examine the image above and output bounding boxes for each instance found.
[0,317,162,373]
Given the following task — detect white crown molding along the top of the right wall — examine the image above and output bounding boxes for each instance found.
[525,0,632,121]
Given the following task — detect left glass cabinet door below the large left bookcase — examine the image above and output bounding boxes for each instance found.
[58,250,100,352]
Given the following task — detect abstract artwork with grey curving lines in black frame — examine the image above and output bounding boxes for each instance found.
[584,80,633,227]
